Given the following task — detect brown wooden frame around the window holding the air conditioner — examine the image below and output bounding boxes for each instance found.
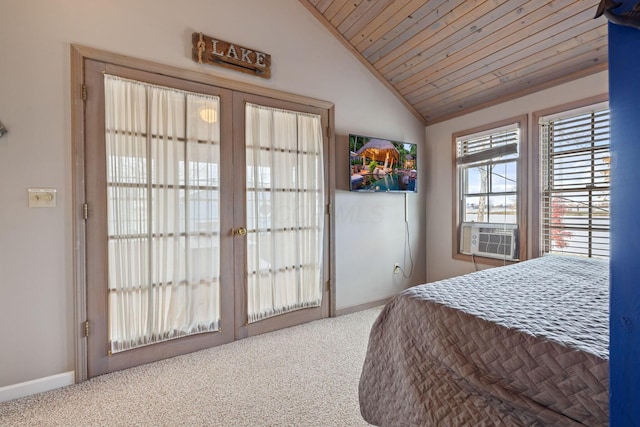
[451,114,529,266]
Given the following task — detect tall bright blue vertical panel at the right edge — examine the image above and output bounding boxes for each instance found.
[609,1,640,427]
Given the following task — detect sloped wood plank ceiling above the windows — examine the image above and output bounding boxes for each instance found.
[299,0,607,124]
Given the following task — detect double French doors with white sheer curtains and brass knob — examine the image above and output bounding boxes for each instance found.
[83,59,329,377]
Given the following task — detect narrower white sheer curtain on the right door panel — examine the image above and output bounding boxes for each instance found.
[246,104,325,323]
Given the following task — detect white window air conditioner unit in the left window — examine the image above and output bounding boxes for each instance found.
[460,222,518,260]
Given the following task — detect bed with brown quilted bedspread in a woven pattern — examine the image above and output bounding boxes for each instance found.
[359,255,609,427]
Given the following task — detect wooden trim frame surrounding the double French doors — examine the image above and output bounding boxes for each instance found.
[70,44,336,382]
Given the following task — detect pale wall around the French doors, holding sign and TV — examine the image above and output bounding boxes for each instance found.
[0,0,426,387]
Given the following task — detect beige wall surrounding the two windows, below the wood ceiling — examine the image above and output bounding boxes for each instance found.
[425,72,608,281]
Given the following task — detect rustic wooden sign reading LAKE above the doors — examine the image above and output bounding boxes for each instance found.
[191,33,271,79]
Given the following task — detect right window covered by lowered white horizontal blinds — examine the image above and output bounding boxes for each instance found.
[539,103,611,257]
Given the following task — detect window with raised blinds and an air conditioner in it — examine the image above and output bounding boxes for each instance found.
[454,117,526,264]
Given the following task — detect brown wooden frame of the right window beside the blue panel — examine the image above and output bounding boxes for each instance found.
[529,93,609,257]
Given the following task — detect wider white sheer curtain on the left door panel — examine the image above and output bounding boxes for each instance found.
[105,75,220,353]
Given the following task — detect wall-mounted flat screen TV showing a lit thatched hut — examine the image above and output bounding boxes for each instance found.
[349,134,418,193]
